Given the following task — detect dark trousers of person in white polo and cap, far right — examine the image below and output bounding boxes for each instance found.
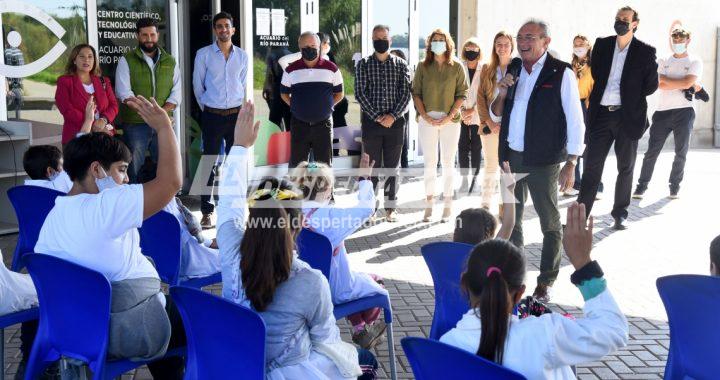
[638,107,695,190]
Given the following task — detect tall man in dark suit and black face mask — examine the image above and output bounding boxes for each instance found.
[578,7,658,230]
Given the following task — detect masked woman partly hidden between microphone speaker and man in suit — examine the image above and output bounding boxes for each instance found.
[563,34,603,199]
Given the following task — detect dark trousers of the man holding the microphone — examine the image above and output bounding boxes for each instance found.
[509,151,562,286]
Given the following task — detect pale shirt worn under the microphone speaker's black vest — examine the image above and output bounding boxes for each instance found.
[489,53,585,156]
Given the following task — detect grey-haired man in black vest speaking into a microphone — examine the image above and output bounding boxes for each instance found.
[490,19,585,302]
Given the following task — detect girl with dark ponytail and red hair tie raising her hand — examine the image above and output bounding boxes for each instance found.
[440,203,628,379]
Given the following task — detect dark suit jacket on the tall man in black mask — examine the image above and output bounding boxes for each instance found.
[588,36,658,140]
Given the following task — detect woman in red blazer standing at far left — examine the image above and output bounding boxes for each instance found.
[55,44,118,145]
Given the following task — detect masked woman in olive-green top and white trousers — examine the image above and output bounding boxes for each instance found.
[412,29,468,222]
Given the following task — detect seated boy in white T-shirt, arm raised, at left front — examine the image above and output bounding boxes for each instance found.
[35,96,185,378]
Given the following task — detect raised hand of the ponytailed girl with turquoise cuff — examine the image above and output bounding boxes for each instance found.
[563,202,593,270]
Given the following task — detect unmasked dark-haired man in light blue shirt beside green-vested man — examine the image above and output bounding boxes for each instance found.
[193,12,248,228]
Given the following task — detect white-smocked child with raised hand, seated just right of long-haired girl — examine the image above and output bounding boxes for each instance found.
[290,154,388,348]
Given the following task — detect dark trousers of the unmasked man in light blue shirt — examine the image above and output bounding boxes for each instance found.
[200,111,237,215]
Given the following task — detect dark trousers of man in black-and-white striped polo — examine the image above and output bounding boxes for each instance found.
[289,117,332,168]
